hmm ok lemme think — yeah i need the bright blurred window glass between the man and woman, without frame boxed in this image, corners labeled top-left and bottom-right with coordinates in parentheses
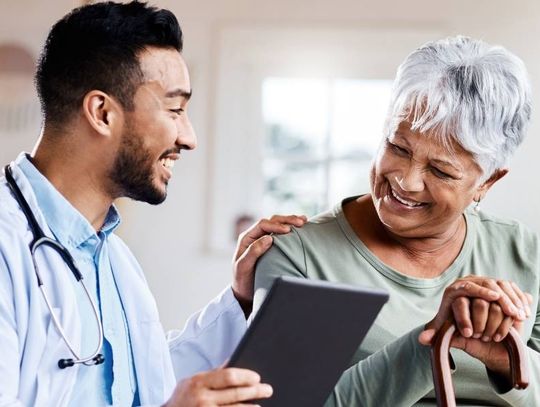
top-left (262, 77), bottom-right (392, 215)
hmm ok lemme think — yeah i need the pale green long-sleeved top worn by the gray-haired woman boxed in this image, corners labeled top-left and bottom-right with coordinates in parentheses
top-left (254, 198), bottom-right (540, 407)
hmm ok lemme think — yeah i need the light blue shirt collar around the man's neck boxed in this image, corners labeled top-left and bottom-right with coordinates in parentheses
top-left (16, 154), bottom-right (120, 248)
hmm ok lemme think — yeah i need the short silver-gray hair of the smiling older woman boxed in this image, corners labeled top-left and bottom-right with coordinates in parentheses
top-left (385, 36), bottom-right (531, 180)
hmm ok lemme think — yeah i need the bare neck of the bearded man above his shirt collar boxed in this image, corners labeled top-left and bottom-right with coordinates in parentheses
top-left (31, 140), bottom-right (113, 231)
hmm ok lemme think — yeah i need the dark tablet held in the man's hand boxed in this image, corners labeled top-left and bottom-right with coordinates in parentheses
top-left (228, 277), bottom-right (388, 407)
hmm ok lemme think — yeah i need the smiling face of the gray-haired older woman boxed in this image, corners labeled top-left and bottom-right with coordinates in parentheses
top-left (371, 121), bottom-right (489, 238)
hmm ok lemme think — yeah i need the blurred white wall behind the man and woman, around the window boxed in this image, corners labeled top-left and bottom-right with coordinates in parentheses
top-left (0, 0), bottom-right (540, 328)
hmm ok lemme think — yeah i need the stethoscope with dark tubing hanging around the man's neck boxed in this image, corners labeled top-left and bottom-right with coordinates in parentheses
top-left (4, 165), bottom-right (105, 369)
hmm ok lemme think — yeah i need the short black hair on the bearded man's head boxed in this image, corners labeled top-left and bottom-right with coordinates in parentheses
top-left (35, 1), bottom-right (182, 126)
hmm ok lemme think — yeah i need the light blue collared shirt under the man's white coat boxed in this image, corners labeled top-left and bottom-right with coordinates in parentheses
top-left (19, 157), bottom-right (139, 406)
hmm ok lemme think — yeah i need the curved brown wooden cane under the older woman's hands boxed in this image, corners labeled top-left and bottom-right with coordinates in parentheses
top-left (431, 321), bottom-right (529, 407)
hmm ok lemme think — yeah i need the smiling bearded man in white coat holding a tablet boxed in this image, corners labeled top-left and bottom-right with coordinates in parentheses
top-left (0, 2), bottom-right (305, 406)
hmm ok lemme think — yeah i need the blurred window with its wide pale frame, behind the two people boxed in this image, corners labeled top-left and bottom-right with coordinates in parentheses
top-left (207, 24), bottom-right (441, 252)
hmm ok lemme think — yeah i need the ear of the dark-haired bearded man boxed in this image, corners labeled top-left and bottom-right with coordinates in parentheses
top-left (82, 90), bottom-right (122, 136)
